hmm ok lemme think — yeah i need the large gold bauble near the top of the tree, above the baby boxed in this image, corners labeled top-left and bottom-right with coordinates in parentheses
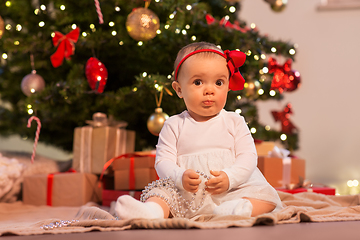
top-left (126, 8), bottom-right (160, 41)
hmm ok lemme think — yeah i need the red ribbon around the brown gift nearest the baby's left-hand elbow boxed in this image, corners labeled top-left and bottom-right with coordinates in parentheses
top-left (98, 153), bottom-right (156, 189)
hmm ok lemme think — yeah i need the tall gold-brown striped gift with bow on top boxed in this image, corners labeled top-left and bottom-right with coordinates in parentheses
top-left (72, 113), bottom-right (135, 174)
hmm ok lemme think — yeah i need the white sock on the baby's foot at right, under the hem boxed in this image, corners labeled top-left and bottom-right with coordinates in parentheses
top-left (214, 199), bottom-right (252, 217)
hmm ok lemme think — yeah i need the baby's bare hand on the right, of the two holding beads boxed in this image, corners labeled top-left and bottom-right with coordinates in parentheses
top-left (205, 170), bottom-right (230, 194)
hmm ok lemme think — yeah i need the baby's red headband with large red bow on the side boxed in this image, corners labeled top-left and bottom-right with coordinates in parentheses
top-left (175, 49), bottom-right (246, 91)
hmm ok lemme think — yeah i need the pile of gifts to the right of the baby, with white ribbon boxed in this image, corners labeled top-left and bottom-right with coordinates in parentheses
top-left (255, 142), bottom-right (335, 195)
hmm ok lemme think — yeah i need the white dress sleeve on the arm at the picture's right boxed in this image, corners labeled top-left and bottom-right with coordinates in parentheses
top-left (223, 116), bottom-right (257, 190)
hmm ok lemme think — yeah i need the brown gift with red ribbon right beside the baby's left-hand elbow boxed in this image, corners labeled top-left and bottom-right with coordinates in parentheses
top-left (112, 152), bottom-right (158, 190)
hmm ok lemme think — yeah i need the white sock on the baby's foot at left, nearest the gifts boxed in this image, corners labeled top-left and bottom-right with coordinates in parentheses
top-left (115, 195), bottom-right (164, 220)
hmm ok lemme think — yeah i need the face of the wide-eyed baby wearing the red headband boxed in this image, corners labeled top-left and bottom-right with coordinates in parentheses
top-left (173, 54), bottom-right (229, 121)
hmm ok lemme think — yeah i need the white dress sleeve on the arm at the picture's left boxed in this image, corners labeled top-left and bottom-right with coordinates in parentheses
top-left (155, 119), bottom-right (185, 190)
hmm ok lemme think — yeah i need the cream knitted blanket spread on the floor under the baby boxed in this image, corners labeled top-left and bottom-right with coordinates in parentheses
top-left (0, 192), bottom-right (360, 236)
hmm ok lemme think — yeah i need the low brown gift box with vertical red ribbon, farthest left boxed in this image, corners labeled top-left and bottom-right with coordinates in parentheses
top-left (23, 173), bottom-right (101, 206)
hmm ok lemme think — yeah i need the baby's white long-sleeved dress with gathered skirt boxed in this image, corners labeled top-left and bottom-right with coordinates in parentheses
top-left (142, 110), bottom-right (282, 218)
